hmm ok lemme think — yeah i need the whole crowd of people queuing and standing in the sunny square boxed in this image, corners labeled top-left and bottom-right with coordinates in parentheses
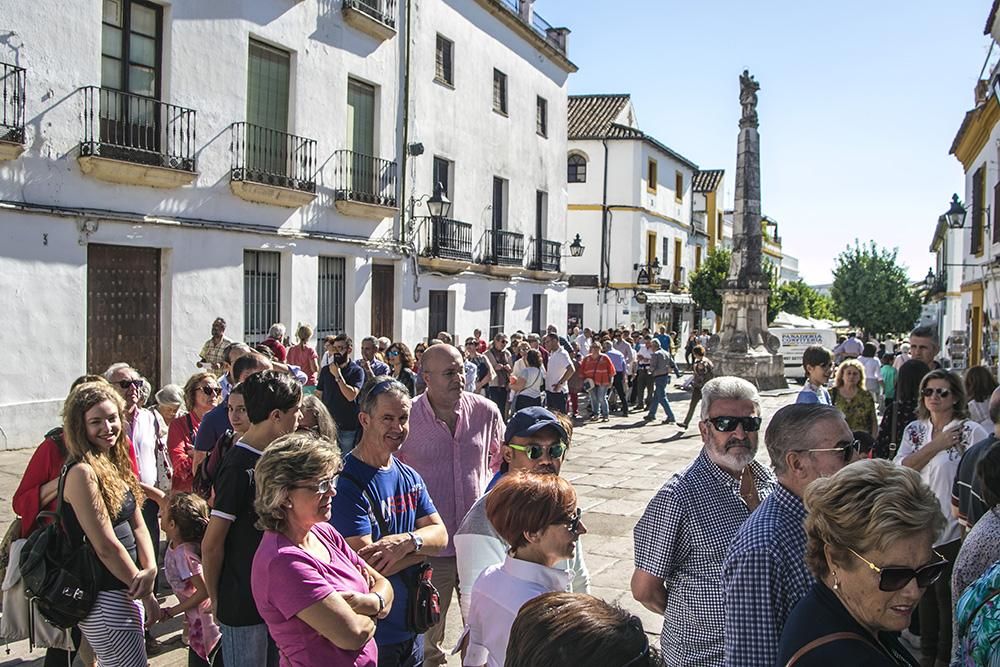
top-left (7, 318), bottom-right (1000, 667)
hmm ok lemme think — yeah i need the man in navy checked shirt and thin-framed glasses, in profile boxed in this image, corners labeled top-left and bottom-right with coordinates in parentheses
top-left (722, 403), bottom-right (860, 667)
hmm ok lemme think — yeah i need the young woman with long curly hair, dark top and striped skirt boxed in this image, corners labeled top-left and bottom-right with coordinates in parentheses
top-left (63, 382), bottom-right (159, 665)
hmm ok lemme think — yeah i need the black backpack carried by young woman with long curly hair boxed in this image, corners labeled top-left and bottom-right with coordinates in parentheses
top-left (19, 462), bottom-right (98, 629)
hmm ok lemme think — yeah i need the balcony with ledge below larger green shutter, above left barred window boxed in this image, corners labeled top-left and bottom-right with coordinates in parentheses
top-left (229, 122), bottom-right (316, 208)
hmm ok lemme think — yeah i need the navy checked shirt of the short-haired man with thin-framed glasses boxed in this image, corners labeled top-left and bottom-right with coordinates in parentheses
top-left (722, 484), bottom-right (816, 667)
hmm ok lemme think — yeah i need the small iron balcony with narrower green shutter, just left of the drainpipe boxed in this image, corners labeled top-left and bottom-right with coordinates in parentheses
top-left (333, 151), bottom-right (397, 220)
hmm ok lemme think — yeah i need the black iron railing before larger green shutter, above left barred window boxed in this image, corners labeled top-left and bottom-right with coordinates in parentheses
top-left (229, 122), bottom-right (316, 193)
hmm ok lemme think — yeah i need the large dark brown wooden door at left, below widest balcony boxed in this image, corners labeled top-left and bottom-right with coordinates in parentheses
top-left (87, 243), bottom-right (160, 391)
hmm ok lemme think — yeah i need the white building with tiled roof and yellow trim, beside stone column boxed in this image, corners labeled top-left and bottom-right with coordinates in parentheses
top-left (566, 95), bottom-right (708, 339)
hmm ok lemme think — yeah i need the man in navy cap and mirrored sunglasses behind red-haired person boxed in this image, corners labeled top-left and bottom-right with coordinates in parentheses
top-left (452, 406), bottom-right (590, 618)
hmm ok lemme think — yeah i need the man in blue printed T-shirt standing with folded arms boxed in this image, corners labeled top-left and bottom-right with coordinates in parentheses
top-left (330, 376), bottom-right (448, 667)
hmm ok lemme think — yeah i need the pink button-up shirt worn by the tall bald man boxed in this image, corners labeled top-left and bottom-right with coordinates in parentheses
top-left (396, 391), bottom-right (504, 556)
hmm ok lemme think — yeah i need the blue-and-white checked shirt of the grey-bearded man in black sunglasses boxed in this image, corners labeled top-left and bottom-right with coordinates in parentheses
top-left (633, 449), bottom-right (775, 667)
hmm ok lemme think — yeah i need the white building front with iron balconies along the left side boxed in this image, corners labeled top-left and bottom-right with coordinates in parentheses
top-left (0, 0), bottom-right (574, 448)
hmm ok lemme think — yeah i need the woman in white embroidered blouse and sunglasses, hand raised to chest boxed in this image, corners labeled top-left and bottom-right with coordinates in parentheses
top-left (894, 370), bottom-right (987, 664)
